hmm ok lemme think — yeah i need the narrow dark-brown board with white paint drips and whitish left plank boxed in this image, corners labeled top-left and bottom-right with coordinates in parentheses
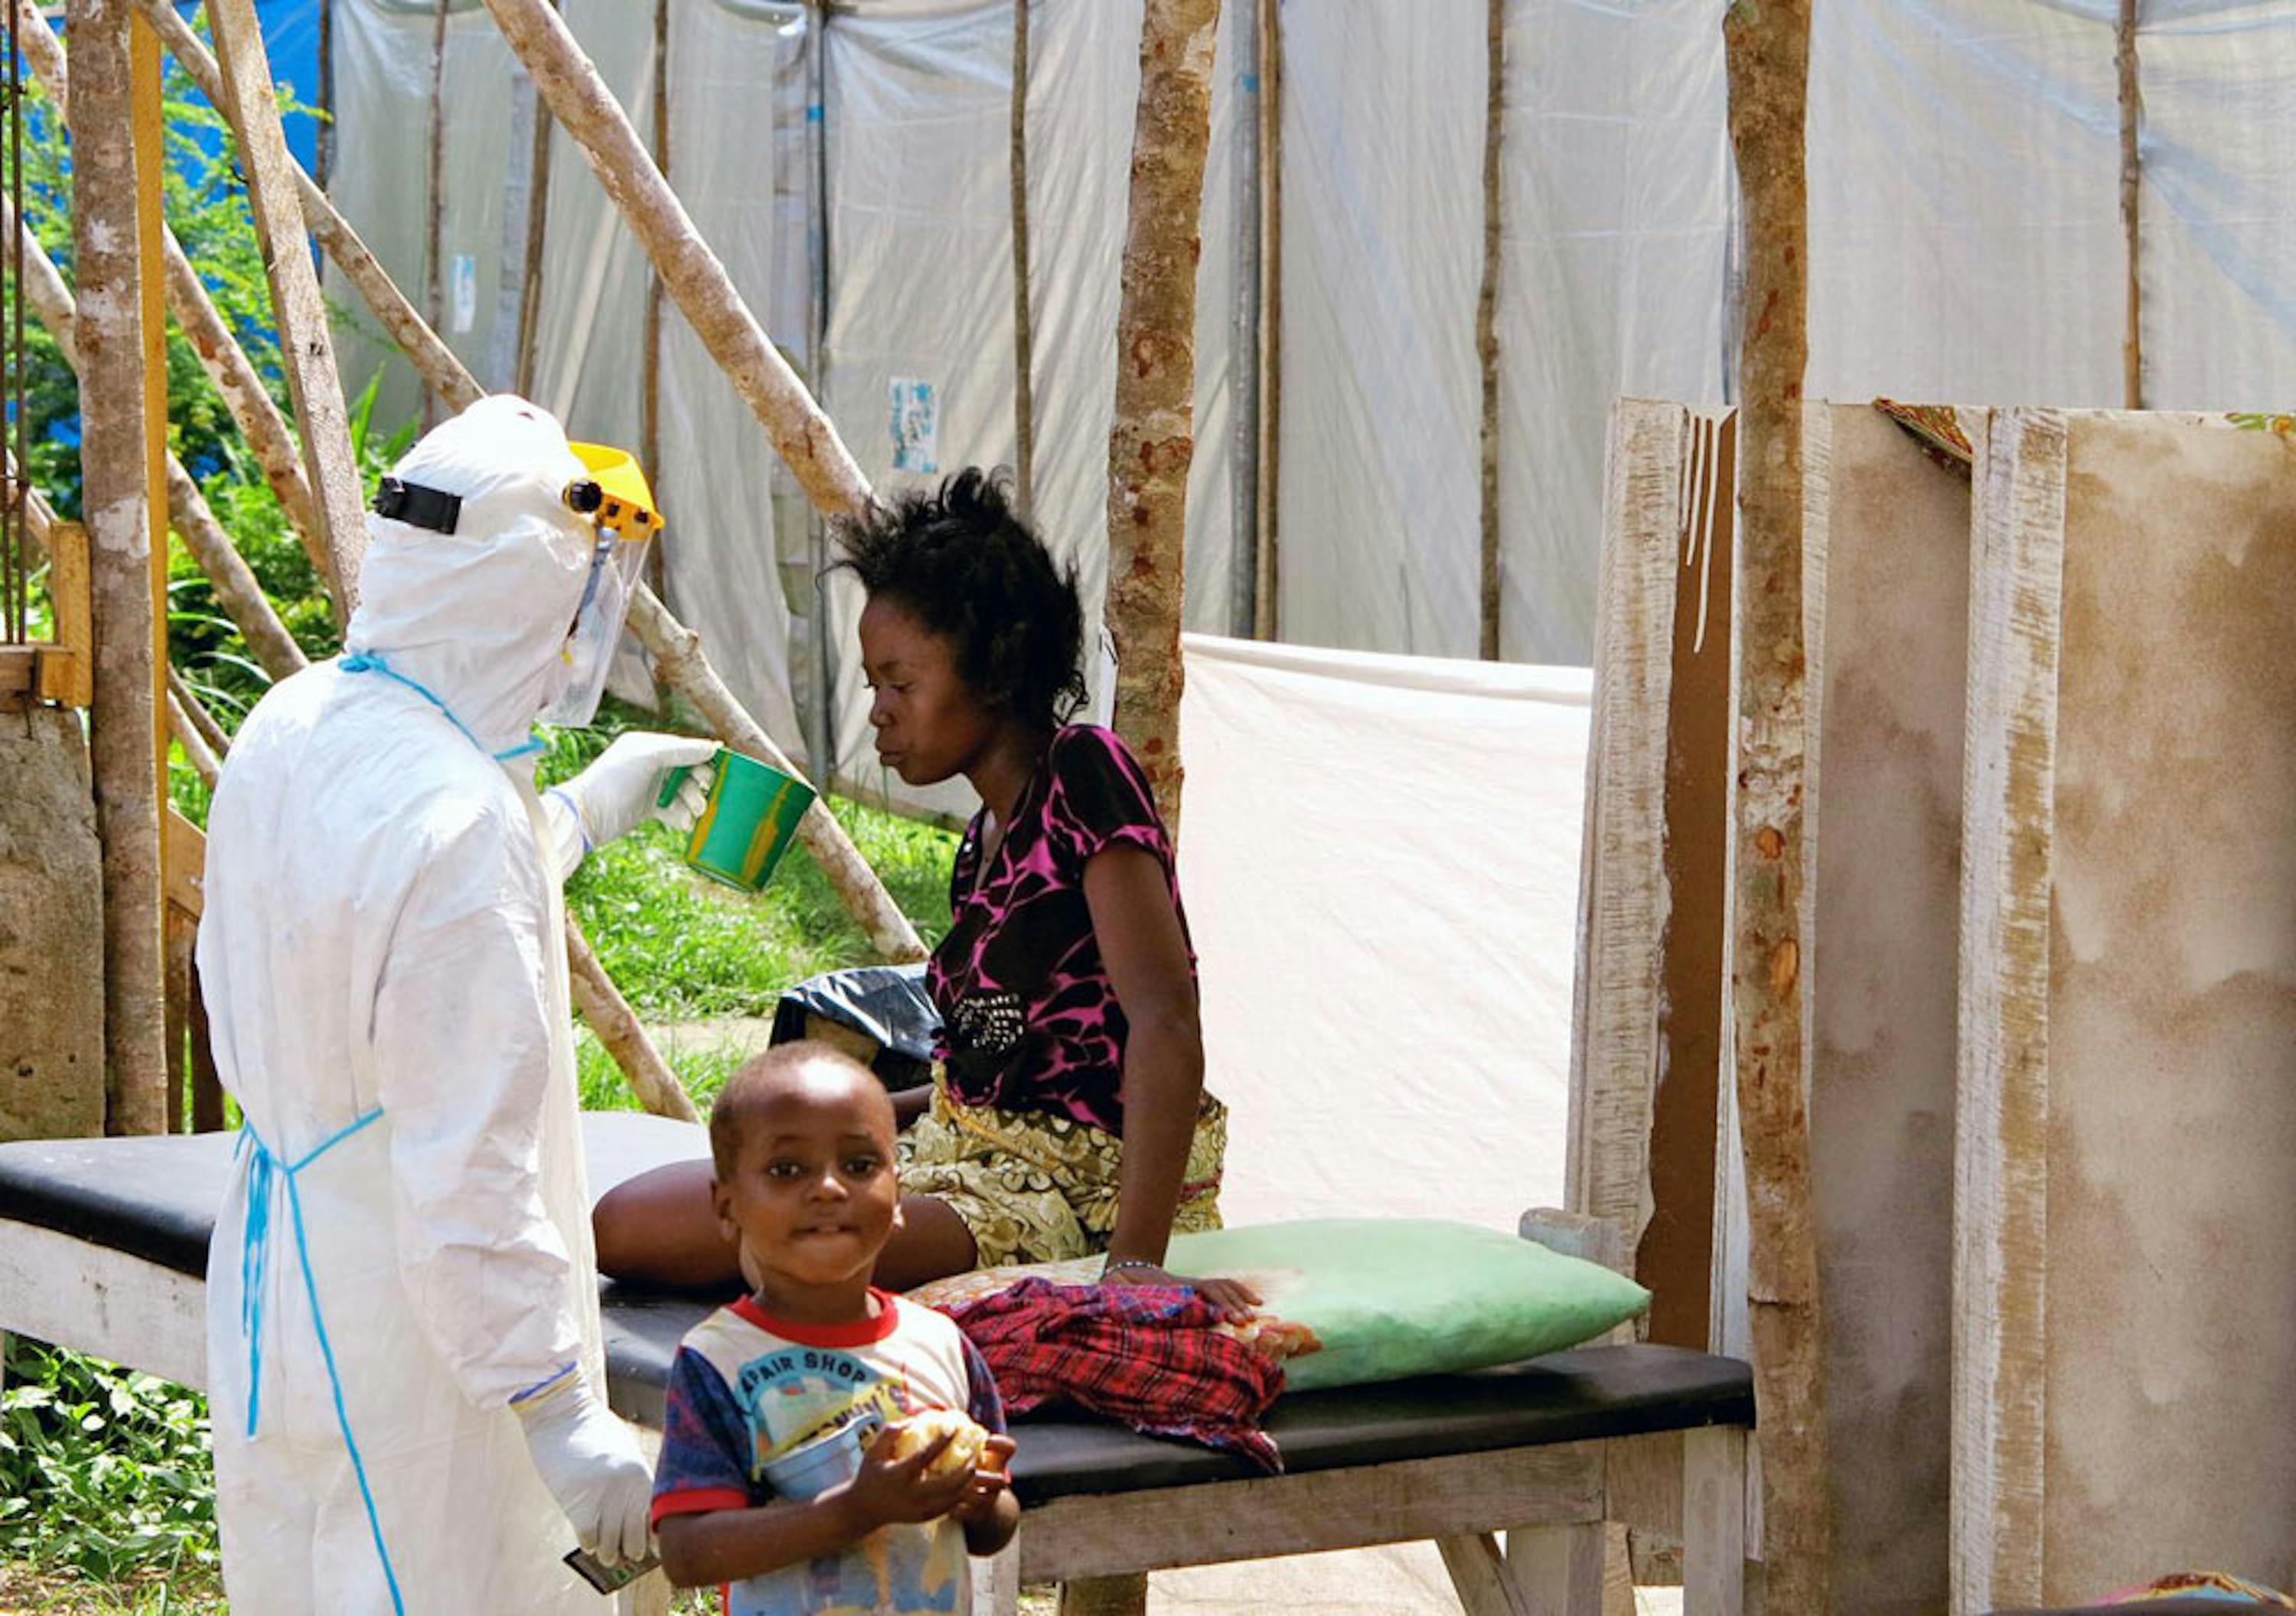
top-left (1564, 399), bottom-right (1731, 1295)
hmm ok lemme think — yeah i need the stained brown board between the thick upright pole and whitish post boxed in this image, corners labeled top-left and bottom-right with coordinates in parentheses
top-left (1805, 404), bottom-right (1970, 1616)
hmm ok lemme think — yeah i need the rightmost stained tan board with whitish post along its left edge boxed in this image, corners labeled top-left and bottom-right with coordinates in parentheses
top-left (1954, 411), bottom-right (2296, 1611)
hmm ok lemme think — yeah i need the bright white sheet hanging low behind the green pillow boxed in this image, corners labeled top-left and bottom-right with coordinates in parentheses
top-left (1180, 636), bottom-right (1589, 1228)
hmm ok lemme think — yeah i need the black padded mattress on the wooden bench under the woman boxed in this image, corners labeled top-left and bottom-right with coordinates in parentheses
top-left (0, 1113), bottom-right (1754, 1504)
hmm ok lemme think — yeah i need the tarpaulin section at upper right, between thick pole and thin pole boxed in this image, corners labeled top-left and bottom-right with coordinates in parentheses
top-left (1802, 0), bottom-right (2124, 404)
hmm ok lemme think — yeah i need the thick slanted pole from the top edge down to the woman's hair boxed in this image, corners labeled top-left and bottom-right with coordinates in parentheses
top-left (480, 0), bottom-right (870, 516)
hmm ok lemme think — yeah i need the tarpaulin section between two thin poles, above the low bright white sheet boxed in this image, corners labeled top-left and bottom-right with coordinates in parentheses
top-left (1277, 0), bottom-right (1488, 656)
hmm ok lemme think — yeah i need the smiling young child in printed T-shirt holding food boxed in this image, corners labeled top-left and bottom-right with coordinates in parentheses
top-left (654, 1042), bottom-right (1019, 1616)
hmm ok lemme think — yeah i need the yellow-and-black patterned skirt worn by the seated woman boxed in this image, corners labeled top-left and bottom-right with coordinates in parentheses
top-left (900, 1067), bottom-right (1228, 1267)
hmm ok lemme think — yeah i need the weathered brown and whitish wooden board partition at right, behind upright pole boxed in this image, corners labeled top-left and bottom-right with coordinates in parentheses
top-left (1598, 404), bottom-right (2296, 1614)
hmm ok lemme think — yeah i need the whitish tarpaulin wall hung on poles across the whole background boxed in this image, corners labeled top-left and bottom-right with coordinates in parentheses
top-left (333, 0), bottom-right (2296, 771)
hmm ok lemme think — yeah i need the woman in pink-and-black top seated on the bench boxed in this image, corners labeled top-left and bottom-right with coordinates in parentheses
top-left (592, 471), bottom-right (1258, 1315)
